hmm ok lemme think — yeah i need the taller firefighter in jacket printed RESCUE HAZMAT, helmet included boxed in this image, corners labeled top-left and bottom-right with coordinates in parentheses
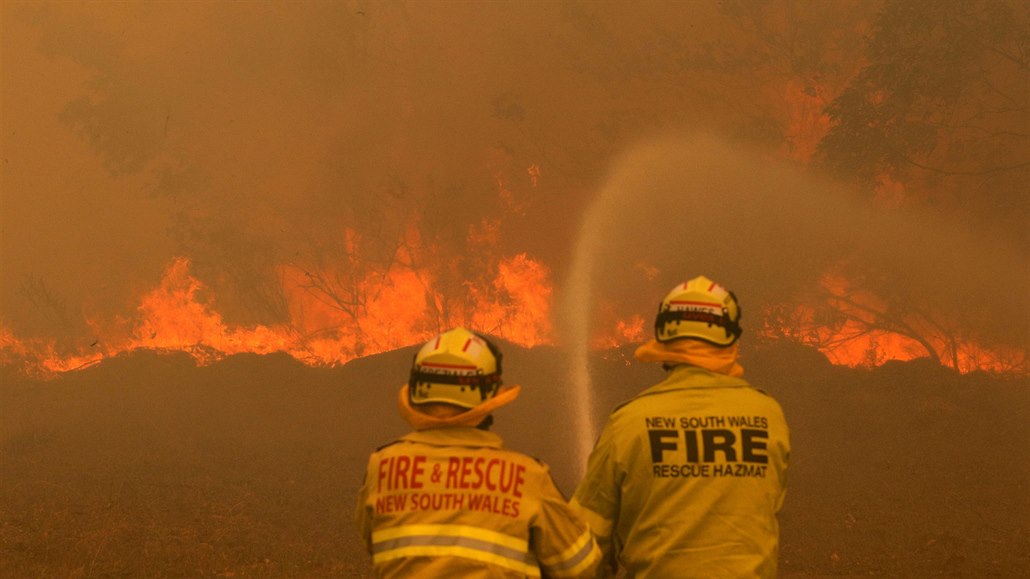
top-left (572, 276), bottom-right (790, 579)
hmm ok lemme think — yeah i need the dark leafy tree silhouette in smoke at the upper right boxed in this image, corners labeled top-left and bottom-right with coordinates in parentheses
top-left (819, 0), bottom-right (1030, 229)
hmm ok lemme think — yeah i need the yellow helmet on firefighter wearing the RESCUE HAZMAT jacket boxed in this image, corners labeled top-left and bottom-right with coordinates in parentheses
top-left (654, 275), bottom-right (742, 347)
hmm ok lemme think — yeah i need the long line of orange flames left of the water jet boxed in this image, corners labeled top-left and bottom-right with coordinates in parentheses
top-left (0, 235), bottom-right (552, 375)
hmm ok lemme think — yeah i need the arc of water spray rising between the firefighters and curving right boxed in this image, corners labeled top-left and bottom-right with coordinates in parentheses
top-left (561, 134), bottom-right (1030, 478)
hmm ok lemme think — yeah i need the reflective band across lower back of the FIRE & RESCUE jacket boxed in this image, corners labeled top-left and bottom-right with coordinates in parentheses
top-left (372, 524), bottom-right (540, 577)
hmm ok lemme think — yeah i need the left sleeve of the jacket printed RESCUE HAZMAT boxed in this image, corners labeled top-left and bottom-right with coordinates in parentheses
top-left (572, 423), bottom-right (623, 577)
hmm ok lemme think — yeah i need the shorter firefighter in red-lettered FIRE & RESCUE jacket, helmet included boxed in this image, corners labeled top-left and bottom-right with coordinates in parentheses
top-left (357, 328), bottom-right (600, 578)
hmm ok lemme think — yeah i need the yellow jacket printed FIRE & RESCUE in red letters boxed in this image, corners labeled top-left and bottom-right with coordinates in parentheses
top-left (357, 427), bottom-right (600, 578)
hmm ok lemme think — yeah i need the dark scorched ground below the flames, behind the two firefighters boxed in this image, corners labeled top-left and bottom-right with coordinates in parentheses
top-left (0, 339), bottom-right (1030, 579)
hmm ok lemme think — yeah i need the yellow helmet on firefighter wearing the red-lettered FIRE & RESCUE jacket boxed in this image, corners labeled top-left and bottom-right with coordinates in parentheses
top-left (408, 328), bottom-right (501, 408)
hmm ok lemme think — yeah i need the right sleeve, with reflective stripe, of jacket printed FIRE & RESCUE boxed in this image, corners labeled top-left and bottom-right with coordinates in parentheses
top-left (529, 467), bottom-right (600, 578)
